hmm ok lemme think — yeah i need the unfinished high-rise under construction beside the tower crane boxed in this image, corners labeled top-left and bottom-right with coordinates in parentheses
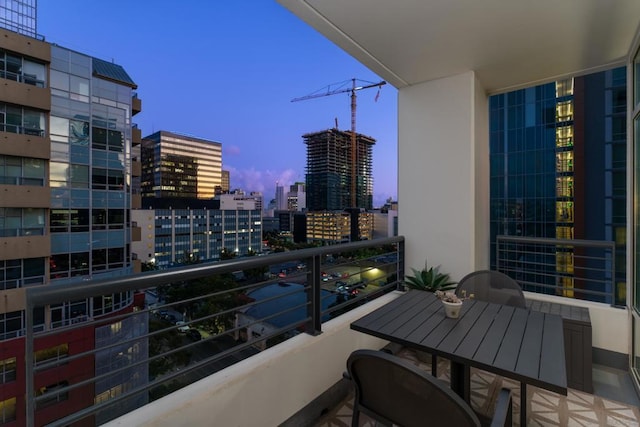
top-left (302, 128), bottom-right (376, 211)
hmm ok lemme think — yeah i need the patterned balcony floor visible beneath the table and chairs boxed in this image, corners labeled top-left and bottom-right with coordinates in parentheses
top-left (315, 349), bottom-right (640, 427)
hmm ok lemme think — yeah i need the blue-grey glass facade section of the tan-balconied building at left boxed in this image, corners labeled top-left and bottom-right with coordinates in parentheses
top-left (49, 46), bottom-right (136, 281)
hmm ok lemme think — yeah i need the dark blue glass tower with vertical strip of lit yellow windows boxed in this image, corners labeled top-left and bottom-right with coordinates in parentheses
top-left (490, 67), bottom-right (627, 303)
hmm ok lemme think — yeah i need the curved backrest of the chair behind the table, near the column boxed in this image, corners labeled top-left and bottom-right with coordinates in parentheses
top-left (456, 270), bottom-right (526, 308)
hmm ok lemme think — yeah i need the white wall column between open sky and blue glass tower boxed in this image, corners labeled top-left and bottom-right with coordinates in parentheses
top-left (398, 71), bottom-right (489, 281)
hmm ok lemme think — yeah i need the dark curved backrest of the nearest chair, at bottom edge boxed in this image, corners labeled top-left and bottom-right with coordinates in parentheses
top-left (347, 350), bottom-right (480, 427)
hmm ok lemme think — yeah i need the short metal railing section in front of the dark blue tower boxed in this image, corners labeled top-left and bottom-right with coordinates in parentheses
top-left (496, 236), bottom-right (625, 306)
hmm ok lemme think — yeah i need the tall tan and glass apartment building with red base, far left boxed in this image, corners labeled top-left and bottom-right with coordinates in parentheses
top-left (0, 15), bottom-right (147, 425)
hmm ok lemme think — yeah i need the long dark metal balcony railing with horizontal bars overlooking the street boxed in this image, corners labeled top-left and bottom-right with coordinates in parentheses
top-left (23, 237), bottom-right (404, 426)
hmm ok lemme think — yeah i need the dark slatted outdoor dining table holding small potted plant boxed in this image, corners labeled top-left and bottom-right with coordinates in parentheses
top-left (351, 290), bottom-right (567, 426)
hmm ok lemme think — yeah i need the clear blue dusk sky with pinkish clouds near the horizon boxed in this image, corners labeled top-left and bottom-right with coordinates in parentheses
top-left (38, 0), bottom-right (398, 206)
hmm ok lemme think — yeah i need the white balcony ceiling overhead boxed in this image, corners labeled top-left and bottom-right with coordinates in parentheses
top-left (277, 0), bottom-right (640, 93)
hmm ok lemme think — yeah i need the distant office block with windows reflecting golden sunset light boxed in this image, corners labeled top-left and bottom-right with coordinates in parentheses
top-left (140, 131), bottom-right (222, 199)
